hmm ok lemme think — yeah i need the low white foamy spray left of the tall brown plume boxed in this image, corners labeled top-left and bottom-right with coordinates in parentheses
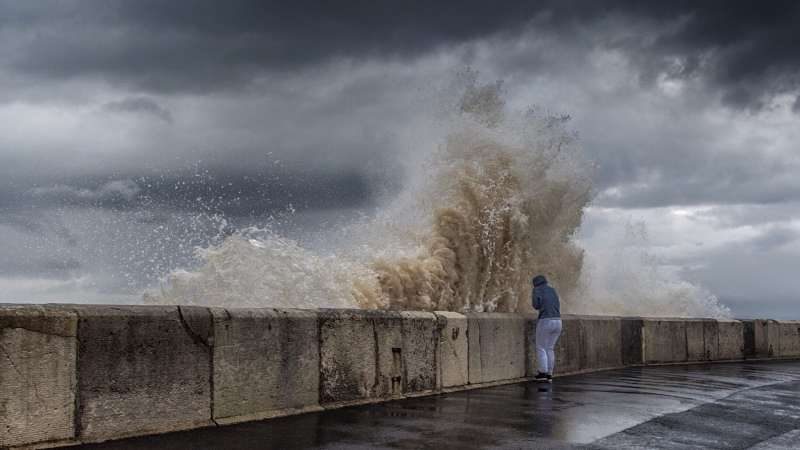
top-left (145, 228), bottom-right (375, 308)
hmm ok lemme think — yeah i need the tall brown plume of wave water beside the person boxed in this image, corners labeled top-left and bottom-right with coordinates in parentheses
top-left (366, 121), bottom-right (589, 311)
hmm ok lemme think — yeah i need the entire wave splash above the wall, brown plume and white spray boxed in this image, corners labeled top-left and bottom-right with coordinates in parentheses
top-left (145, 72), bottom-right (729, 317)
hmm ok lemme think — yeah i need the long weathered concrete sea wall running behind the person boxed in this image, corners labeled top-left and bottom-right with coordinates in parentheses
top-left (0, 305), bottom-right (800, 448)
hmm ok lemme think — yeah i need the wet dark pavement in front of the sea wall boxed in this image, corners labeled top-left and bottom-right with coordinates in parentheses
top-left (73, 362), bottom-right (800, 450)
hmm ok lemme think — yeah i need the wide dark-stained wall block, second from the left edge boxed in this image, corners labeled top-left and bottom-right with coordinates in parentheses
top-left (76, 305), bottom-right (212, 440)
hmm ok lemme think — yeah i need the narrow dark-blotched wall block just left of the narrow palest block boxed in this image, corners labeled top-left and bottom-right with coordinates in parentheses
top-left (400, 312), bottom-right (439, 394)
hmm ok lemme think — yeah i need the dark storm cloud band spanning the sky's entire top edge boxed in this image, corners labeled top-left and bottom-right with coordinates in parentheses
top-left (0, 0), bottom-right (800, 107)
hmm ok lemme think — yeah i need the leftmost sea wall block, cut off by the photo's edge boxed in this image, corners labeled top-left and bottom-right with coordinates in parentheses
top-left (0, 306), bottom-right (78, 447)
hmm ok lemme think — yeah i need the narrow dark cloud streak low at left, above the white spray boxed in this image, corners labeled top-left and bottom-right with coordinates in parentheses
top-left (0, 170), bottom-right (373, 216)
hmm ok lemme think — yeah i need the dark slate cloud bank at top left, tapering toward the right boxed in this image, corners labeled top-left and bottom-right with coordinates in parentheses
top-left (3, 1), bottom-right (536, 92)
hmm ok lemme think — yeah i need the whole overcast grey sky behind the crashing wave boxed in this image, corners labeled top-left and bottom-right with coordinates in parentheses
top-left (0, 0), bottom-right (800, 318)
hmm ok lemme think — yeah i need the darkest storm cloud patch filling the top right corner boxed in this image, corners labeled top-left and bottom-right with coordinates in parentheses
top-left (620, 1), bottom-right (800, 108)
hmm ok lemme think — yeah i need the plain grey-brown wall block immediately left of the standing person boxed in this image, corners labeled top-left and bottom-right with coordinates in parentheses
top-left (467, 313), bottom-right (526, 384)
